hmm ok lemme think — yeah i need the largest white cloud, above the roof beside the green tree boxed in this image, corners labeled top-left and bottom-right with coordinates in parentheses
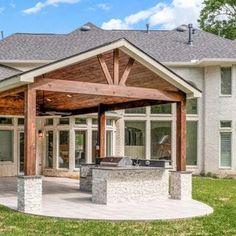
top-left (102, 0), bottom-right (203, 29)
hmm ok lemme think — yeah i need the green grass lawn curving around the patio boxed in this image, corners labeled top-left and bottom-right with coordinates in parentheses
top-left (0, 177), bottom-right (236, 236)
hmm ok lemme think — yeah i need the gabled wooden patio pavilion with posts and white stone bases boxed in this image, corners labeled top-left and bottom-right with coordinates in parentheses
top-left (0, 39), bottom-right (205, 218)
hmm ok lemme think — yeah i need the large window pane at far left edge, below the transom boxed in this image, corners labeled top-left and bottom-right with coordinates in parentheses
top-left (0, 130), bottom-right (13, 161)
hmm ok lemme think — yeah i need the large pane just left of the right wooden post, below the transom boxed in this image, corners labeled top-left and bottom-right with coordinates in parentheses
top-left (151, 121), bottom-right (171, 160)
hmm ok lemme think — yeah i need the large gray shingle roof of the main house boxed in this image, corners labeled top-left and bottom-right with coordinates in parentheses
top-left (0, 23), bottom-right (236, 62)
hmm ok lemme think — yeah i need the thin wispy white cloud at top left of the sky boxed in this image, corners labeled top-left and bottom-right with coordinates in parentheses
top-left (23, 0), bottom-right (80, 14)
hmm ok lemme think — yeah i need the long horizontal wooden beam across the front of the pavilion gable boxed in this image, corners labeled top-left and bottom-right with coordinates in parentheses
top-left (31, 79), bottom-right (183, 102)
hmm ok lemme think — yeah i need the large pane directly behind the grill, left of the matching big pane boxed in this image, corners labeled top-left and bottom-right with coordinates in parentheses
top-left (125, 121), bottom-right (145, 159)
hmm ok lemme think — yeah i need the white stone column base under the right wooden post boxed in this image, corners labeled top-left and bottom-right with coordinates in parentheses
top-left (170, 171), bottom-right (192, 200)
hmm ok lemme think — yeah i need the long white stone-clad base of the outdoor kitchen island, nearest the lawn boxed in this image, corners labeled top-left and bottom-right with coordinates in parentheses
top-left (92, 167), bottom-right (169, 204)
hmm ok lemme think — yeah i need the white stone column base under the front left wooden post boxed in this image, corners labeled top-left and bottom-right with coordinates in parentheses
top-left (17, 176), bottom-right (42, 213)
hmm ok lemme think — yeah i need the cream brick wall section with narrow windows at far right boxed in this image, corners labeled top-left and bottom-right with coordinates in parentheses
top-left (204, 65), bottom-right (236, 175)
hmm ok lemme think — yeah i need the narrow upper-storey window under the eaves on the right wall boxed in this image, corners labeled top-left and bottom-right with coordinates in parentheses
top-left (221, 67), bottom-right (232, 95)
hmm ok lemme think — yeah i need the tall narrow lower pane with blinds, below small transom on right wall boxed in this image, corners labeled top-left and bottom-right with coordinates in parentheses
top-left (220, 132), bottom-right (231, 167)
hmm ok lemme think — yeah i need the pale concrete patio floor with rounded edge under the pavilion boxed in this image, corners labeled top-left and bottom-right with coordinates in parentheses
top-left (0, 177), bottom-right (213, 220)
